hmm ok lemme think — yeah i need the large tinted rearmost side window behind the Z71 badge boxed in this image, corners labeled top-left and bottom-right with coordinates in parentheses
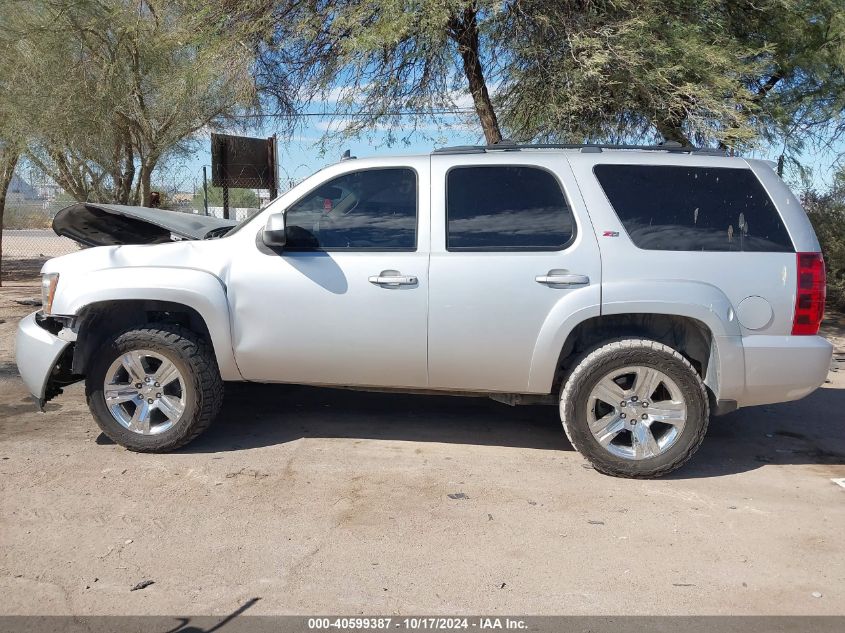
top-left (594, 165), bottom-right (795, 252)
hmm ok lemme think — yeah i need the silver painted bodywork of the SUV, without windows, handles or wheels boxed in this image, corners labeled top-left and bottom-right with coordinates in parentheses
top-left (19, 151), bottom-right (831, 406)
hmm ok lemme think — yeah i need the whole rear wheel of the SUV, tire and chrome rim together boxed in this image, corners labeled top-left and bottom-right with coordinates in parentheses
top-left (560, 338), bottom-right (710, 479)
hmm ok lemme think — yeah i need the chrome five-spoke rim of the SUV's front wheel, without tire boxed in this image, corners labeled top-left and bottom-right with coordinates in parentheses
top-left (103, 349), bottom-right (185, 435)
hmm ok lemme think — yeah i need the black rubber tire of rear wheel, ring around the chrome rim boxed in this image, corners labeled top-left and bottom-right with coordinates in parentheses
top-left (560, 338), bottom-right (710, 479)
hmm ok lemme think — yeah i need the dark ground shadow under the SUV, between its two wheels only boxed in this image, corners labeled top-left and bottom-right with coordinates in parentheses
top-left (183, 383), bottom-right (572, 453)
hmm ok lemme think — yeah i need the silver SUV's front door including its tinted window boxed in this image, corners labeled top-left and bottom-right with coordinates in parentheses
top-left (228, 157), bottom-right (429, 388)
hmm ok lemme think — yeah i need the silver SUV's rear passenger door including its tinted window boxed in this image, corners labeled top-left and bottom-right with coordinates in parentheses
top-left (428, 152), bottom-right (601, 392)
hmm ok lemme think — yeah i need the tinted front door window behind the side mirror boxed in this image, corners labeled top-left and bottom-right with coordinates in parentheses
top-left (285, 168), bottom-right (417, 251)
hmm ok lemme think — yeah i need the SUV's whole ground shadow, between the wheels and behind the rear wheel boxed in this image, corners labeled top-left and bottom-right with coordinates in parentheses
top-left (168, 383), bottom-right (845, 479)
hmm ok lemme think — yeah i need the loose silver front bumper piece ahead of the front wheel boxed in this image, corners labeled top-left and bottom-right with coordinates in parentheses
top-left (15, 312), bottom-right (70, 408)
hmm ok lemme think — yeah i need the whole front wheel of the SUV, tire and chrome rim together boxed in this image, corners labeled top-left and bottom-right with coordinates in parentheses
top-left (85, 323), bottom-right (223, 453)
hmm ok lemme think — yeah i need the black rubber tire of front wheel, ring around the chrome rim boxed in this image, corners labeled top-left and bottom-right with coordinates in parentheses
top-left (85, 323), bottom-right (223, 453)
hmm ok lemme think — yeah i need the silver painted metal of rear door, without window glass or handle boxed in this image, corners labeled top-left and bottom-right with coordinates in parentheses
top-left (428, 153), bottom-right (602, 393)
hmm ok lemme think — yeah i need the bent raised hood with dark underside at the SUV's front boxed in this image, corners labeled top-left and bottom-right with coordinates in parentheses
top-left (53, 202), bottom-right (237, 246)
